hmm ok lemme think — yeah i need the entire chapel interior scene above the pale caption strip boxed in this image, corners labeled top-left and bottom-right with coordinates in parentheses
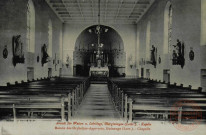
top-left (0, 0), bottom-right (206, 134)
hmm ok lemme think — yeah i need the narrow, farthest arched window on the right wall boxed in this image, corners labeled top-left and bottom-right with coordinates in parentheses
top-left (146, 21), bottom-right (151, 60)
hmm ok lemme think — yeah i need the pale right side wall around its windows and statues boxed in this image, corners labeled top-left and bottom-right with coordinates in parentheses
top-left (137, 0), bottom-right (201, 88)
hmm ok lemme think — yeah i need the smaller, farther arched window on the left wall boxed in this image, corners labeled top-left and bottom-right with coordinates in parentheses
top-left (48, 20), bottom-right (52, 57)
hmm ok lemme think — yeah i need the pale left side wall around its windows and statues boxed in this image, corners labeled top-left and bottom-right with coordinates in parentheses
top-left (0, 0), bottom-right (62, 85)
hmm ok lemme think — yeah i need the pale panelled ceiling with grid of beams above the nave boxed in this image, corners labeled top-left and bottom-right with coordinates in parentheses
top-left (46, 0), bottom-right (155, 24)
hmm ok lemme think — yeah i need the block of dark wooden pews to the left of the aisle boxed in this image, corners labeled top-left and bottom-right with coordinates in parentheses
top-left (0, 78), bottom-right (90, 120)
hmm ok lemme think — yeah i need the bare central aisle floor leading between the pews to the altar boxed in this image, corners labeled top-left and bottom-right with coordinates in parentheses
top-left (75, 84), bottom-right (120, 120)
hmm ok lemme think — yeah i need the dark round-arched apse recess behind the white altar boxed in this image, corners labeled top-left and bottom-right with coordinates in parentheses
top-left (73, 25), bottom-right (126, 77)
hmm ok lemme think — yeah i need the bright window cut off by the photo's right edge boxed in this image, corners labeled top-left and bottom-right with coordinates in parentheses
top-left (201, 0), bottom-right (206, 46)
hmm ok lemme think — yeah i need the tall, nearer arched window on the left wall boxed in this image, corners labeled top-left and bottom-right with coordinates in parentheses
top-left (27, 0), bottom-right (35, 53)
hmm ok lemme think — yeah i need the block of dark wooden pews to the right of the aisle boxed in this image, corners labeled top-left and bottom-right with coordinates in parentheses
top-left (108, 78), bottom-right (206, 122)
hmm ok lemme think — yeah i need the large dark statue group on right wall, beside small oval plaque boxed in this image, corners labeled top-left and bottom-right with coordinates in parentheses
top-left (172, 39), bottom-right (185, 68)
